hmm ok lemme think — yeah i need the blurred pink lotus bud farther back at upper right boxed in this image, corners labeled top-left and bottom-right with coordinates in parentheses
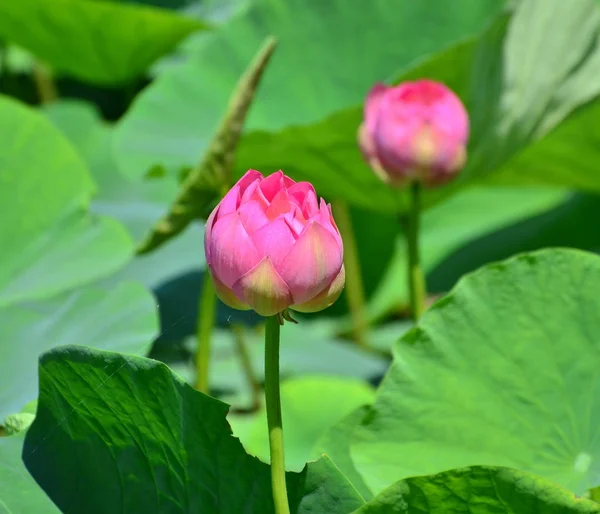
top-left (358, 80), bottom-right (469, 186)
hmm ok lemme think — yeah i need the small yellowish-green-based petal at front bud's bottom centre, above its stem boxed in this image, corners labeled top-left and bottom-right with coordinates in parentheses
top-left (233, 257), bottom-right (293, 316)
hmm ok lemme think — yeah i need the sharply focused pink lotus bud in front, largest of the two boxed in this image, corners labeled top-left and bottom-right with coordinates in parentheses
top-left (204, 170), bottom-right (344, 316)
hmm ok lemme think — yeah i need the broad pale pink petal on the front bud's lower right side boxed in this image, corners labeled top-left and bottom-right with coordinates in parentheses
top-left (277, 221), bottom-right (343, 304)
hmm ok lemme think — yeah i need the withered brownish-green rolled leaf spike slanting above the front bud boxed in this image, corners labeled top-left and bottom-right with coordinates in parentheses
top-left (137, 36), bottom-right (277, 255)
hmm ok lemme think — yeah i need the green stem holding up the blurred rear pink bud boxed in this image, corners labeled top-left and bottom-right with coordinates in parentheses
top-left (406, 181), bottom-right (427, 321)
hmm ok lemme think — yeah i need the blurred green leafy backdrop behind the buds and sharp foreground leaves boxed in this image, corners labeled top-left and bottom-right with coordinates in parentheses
top-left (0, 0), bottom-right (600, 508)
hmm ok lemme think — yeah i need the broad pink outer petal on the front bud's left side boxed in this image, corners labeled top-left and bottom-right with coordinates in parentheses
top-left (209, 212), bottom-right (260, 288)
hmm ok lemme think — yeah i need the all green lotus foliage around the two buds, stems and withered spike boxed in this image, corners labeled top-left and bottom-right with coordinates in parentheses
top-left (0, 0), bottom-right (600, 514)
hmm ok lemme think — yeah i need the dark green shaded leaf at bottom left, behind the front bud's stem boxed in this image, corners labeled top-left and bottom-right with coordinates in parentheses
top-left (23, 347), bottom-right (363, 514)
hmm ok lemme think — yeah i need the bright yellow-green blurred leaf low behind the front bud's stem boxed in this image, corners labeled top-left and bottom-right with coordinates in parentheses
top-left (228, 376), bottom-right (374, 471)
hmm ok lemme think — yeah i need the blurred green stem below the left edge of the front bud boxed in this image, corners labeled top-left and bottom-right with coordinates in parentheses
top-left (196, 271), bottom-right (217, 394)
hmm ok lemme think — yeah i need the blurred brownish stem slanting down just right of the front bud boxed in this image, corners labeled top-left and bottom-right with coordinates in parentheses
top-left (332, 201), bottom-right (369, 348)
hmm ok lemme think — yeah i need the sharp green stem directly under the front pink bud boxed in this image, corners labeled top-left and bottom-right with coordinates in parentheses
top-left (265, 315), bottom-right (290, 514)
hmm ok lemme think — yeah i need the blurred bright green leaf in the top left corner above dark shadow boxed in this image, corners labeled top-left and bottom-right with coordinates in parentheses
top-left (0, 0), bottom-right (204, 84)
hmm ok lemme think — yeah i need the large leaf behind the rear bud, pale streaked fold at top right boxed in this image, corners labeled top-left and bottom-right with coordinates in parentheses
top-left (238, 0), bottom-right (600, 211)
